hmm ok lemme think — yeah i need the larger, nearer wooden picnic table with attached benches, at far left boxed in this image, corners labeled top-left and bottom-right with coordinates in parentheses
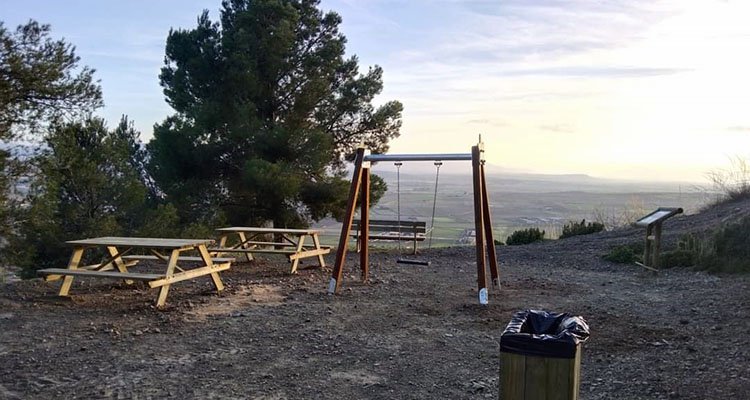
top-left (38, 237), bottom-right (233, 307)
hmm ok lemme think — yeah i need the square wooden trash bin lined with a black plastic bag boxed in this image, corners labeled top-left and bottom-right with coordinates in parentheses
top-left (500, 310), bottom-right (589, 400)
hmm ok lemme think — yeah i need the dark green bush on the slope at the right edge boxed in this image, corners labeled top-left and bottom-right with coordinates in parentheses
top-left (699, 216), bottom-right (750, 273)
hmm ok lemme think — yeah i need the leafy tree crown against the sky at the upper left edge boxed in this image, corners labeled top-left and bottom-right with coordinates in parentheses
top-left (0, 21), bottom-right (102, 140)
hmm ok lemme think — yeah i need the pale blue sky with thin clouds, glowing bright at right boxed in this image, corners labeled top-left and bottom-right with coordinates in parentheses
top-left (0, 0), bottom-right (750, 182)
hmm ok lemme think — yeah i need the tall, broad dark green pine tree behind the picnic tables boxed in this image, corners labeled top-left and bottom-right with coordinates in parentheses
top-left (148, 0), bottom-right (402, 227)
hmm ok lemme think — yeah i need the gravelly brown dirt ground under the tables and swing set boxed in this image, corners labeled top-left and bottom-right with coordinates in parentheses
top-left (0, 205), bottom-right (750, 399)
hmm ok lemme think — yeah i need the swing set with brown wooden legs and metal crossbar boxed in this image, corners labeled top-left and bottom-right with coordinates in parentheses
top-left (328, 137), bottom-right (499, 305)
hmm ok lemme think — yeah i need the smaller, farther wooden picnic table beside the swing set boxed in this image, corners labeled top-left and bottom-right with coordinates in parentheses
top-left (209, 226), bottom-right (331, 274)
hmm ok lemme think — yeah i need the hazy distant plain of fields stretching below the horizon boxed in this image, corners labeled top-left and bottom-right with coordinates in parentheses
top-left (315, 166), bottom-right (714, 247)
